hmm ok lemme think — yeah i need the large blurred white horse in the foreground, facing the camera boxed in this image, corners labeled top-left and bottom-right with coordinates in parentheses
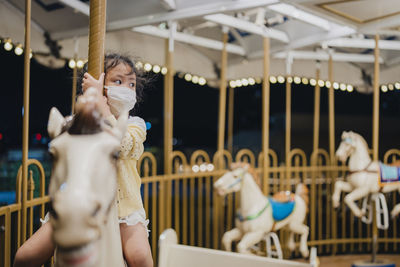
top-left (48, 88), bottom-right (127, 267)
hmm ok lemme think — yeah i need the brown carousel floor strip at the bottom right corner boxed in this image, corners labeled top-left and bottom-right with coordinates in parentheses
top-left (294, 254), bottom-right (400, 267)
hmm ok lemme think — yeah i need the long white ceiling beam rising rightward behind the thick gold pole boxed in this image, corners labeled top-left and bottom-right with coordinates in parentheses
top-left (52, 0), bottom-right (279, 40)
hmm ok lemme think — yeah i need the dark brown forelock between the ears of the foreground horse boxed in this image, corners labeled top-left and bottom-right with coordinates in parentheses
top-left (63, 102), bottom-right (103, 135)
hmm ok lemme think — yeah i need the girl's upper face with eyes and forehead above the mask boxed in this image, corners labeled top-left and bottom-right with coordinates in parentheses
top-left (104, 63), bottom-right (136, 94)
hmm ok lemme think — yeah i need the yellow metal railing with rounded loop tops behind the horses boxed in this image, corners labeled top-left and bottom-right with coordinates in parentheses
top-left (0, 149), bottom-right (400, 267)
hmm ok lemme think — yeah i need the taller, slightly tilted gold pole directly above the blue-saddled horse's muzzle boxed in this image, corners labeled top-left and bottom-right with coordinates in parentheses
top-left (217, 28), bottom-right (228, 169)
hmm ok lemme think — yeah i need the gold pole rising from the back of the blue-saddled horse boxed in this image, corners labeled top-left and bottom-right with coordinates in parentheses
top-left (261, 37), bottom-right (270, 195)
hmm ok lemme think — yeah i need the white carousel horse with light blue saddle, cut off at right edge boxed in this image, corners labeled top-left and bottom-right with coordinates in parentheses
top-left (332, 131), bottom-right (400, 221)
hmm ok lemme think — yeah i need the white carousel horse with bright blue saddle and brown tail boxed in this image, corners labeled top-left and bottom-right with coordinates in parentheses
top-left (214, 163), bottom-right (309, 258)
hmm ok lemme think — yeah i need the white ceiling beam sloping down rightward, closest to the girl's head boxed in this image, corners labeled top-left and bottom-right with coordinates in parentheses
top-left (132, 26), bottom-right (246, 56)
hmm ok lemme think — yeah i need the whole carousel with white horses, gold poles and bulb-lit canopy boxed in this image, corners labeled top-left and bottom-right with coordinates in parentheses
top-left (0, 0), bottom-right (400, 267)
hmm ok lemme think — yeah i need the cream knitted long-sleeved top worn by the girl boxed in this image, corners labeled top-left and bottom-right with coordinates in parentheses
top-left (107, 116), bottom-right (146, 218)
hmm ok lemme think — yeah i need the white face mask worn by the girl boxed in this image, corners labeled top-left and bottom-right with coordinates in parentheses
top-left (104, 86), bottom-right (136, 117)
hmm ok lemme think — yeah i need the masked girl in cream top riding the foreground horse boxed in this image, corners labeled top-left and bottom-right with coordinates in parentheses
top-left (14, 54), bottom-right (153, 267)
